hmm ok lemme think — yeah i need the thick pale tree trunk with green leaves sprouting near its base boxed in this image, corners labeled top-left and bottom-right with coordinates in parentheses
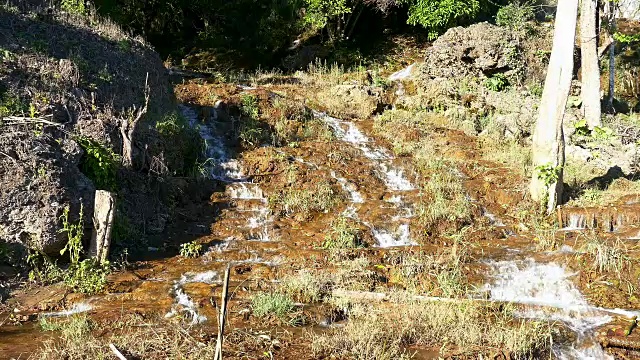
top-left (529, 0), bottom-right (578, 213)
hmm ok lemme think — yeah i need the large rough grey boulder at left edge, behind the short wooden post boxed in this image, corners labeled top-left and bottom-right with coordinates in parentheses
top-left (0, 131), bottom-right (95, 254)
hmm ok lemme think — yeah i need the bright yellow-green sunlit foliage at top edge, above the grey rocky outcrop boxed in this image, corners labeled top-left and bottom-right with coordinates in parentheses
top-left (400, 0), bottom-right (488, 40)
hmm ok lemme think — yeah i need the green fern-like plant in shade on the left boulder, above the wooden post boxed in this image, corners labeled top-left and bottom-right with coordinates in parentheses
top-left (75, 136), bottom-right (120, 190)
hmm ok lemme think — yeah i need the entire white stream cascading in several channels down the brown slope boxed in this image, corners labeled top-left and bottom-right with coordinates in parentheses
top-left (179, 98), bottom-right (636, 360)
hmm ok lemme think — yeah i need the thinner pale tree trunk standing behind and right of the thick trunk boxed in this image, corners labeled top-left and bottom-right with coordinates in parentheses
top-left (580, 0), bottom-right (602, 129)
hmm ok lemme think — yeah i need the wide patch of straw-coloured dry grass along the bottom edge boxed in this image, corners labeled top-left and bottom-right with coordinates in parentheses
top-left (312, 301), bottom-right (551, 360)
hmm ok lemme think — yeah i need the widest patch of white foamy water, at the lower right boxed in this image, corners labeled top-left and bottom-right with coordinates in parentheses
top-left (485, 259), bottom-right (612, 360)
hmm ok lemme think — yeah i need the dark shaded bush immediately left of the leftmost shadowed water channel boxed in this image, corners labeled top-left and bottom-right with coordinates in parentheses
top-left (156, 112), bottom-right (204, 176)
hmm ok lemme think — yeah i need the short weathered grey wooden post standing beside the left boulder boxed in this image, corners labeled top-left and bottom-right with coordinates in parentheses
top-left (89, 190), bottom-right (116, 264)
